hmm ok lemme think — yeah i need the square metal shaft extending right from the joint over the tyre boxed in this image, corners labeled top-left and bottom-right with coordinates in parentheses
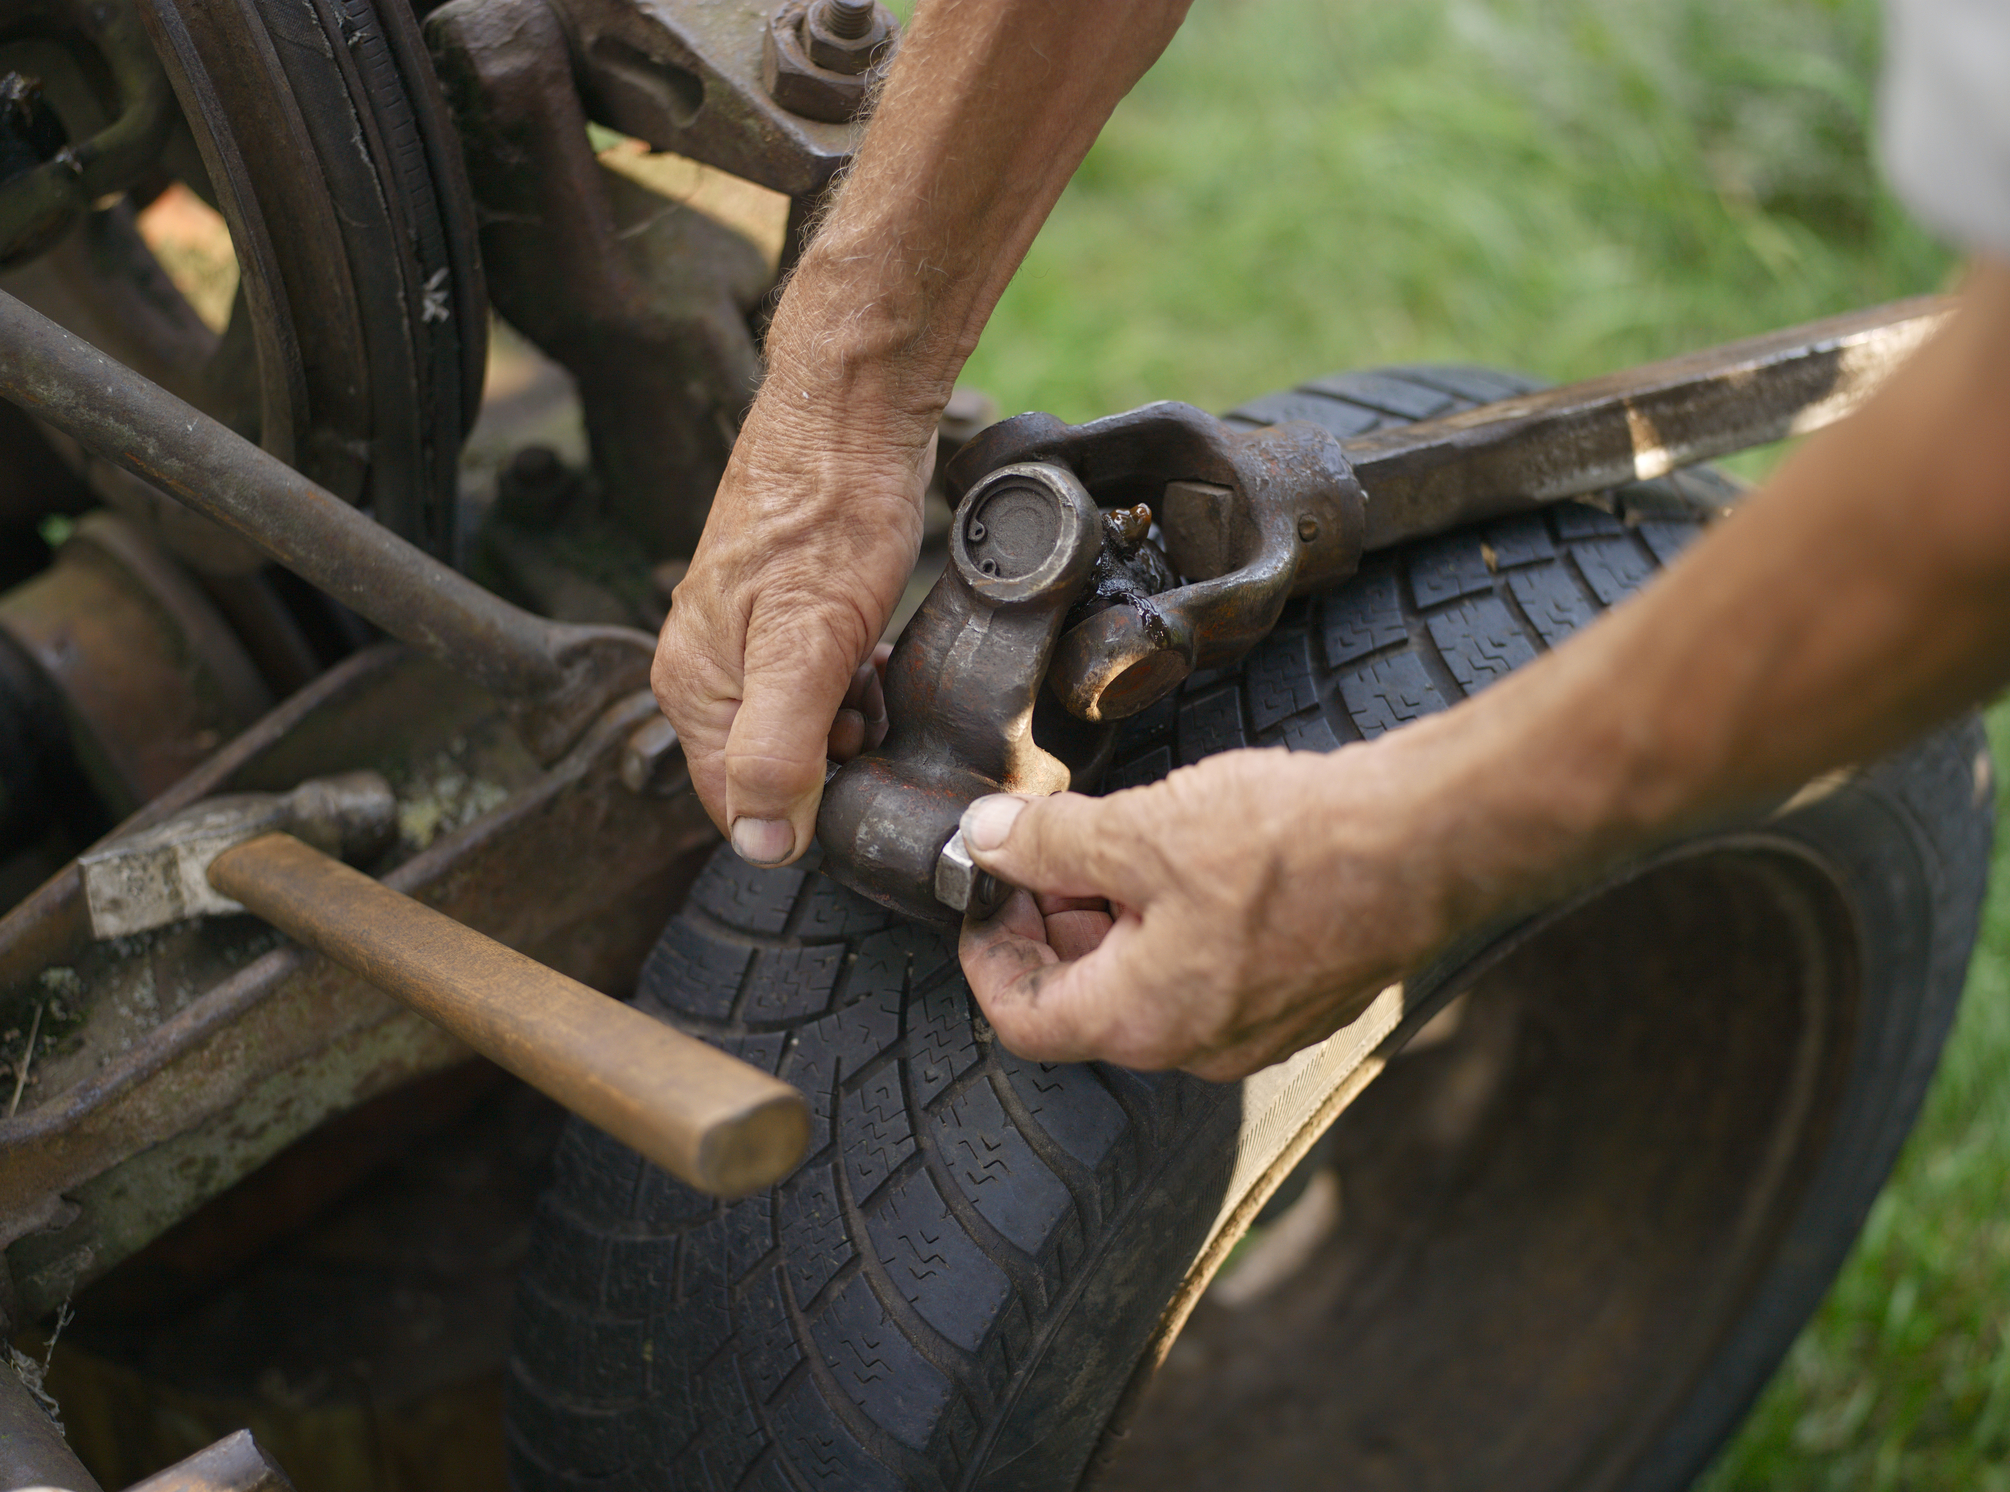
top-left (1343, 296), bottom-right (1952, 549)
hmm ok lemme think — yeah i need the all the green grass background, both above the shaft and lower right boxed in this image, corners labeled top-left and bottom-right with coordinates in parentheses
top-left (967, 0), bottom-right (2010, 1492)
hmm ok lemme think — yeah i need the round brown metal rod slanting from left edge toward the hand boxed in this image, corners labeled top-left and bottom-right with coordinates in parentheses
top-left (0, 292), bottom-right (653, 760)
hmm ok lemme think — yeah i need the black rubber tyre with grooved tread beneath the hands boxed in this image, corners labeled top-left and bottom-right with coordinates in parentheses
top-left (507, 368), bottom-right (1990, 1492)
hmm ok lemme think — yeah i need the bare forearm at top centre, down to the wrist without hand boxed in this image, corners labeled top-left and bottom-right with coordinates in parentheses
top-left (768, 0), bottom-right (1186, 418)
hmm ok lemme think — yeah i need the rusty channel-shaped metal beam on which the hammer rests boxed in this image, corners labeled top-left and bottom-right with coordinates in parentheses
top-left (0, 667), bottom-right (718, 1317)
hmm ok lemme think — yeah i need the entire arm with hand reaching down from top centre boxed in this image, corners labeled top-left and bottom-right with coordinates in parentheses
top-left (651, 0), bottom-right (1186, 865)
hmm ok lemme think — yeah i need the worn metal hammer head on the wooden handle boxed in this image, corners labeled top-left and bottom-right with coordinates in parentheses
top-left (76, 772), bottom-right (398, 939)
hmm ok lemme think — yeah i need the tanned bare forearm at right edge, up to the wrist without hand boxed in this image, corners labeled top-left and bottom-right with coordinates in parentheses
top-left (1407, 265), bottom-right (2010, 928)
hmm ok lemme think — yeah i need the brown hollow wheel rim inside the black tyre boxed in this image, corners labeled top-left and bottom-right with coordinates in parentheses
top-left (1095, 838), bottom-right (1863, 1492)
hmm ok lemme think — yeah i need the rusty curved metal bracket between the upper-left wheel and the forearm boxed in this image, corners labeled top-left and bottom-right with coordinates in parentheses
top-left (426, 0), bottom-right (772, 559)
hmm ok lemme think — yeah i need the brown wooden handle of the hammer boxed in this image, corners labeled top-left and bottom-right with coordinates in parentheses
top-left (209, 834), bottom-right (810, 1196)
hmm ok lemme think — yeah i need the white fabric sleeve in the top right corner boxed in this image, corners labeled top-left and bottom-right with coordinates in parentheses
top-left (1879, 0), bottom-right (2010, 259)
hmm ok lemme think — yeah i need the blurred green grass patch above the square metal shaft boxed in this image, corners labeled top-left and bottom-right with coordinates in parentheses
top-left (969, 0), bottom-right (1948, 450)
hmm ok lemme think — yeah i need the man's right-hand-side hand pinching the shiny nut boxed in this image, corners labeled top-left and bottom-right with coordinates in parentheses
top-left (961, 736), bottom-right (1461, 1082)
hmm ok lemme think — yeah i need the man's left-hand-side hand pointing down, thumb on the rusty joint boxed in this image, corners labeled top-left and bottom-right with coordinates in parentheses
top-left (651, 388), bottom-right (935, 865)
